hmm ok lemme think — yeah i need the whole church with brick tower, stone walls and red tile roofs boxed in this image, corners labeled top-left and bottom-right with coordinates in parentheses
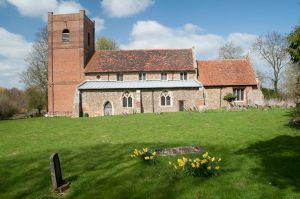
top-left (48, 10), bottom-right (262, 117)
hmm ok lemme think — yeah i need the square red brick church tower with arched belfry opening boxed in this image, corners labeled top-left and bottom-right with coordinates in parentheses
top-left (48, 10), bottom-right (95, 115)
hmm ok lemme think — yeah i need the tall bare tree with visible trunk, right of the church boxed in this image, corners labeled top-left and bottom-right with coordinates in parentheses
top-left (253, 32), bottom-right (290, 93)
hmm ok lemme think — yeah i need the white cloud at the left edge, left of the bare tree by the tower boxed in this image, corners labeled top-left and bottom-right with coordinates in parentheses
top-left (0, 27), bottom-right (31, 87)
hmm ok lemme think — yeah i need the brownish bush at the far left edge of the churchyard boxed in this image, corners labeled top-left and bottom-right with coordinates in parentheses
top-left (0, 94), bottom-right (18, 119)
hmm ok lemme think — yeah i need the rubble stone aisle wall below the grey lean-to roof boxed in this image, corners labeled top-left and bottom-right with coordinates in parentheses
top-left (81, 88), bottom-right (204, 117)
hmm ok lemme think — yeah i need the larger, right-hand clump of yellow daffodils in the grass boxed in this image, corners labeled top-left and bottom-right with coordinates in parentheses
top-left (169, 152), bottom-right (221, 177)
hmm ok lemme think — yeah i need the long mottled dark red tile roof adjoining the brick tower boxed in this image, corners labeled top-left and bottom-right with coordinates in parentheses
top-left (85, 49), bottom-right (195, 73)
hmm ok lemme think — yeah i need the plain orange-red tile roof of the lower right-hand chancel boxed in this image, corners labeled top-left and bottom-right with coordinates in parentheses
top-left (197, 59), bottom-right (257, 86)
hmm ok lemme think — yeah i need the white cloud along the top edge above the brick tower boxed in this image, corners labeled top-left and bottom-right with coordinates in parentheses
top-left (7, 0), bottom-right (84, 21)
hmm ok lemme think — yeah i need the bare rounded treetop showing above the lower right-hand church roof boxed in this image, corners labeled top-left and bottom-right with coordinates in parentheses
top-left (219, 41), bottom-right (244, 59)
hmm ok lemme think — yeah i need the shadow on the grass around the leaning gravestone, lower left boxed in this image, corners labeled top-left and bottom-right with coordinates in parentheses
top-left (0, 144), bottom-right (203, 198)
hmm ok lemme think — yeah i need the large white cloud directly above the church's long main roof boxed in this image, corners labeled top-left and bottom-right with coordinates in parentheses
top-left (121, 21), bottom-right (257, 59)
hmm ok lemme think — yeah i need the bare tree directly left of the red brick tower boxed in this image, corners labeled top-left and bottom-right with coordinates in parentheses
top-left (20, 27), bottom-right (48, 107)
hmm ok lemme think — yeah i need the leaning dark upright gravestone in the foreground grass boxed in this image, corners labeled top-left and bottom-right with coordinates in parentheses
top-left (50, 153), bottom-right (69, 192)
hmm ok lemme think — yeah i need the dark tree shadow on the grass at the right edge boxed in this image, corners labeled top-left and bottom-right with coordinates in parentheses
top-left (237, 135), bottom-right (300, 192)
